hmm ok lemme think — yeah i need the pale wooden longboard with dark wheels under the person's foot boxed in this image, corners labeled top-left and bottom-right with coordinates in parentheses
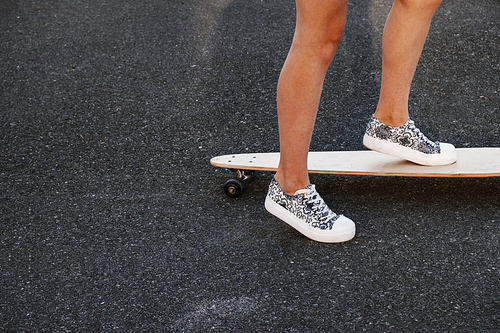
top-left (210, 147), bottom-right (500, 197)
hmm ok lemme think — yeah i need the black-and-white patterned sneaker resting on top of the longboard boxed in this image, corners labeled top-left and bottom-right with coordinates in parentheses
top-left (363, 116), bottom-right (457, 165)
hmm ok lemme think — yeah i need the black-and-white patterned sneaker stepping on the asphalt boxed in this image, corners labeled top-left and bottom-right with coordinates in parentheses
top-left (265, 178), bottom-right (356, 243)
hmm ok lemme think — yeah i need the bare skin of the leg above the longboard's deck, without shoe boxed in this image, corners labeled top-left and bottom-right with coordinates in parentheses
top-left (375, 0), bottom-right (441, 127)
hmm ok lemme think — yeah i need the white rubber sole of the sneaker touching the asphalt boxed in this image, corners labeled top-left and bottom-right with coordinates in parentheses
top-left (264, 197), bottom-right (356, 243)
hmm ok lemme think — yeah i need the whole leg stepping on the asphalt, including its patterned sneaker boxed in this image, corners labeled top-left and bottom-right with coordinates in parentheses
top-left (265, 0), bottom-right (356, 243)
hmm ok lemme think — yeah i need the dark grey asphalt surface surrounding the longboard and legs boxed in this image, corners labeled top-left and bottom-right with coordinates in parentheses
top-left (0, 0), bottom-right (500, 332)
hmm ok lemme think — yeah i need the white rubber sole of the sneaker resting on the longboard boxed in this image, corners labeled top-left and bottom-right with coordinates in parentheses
top-left (363, 134), bottom-right (457, 166)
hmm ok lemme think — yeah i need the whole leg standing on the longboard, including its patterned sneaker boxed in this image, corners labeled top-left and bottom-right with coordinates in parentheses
top-left (363, 0), bottom-right (457, 165)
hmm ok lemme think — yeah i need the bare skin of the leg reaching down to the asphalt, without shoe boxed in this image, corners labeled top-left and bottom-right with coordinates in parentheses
top-left (275, 0), bottom-right (348, 194)
